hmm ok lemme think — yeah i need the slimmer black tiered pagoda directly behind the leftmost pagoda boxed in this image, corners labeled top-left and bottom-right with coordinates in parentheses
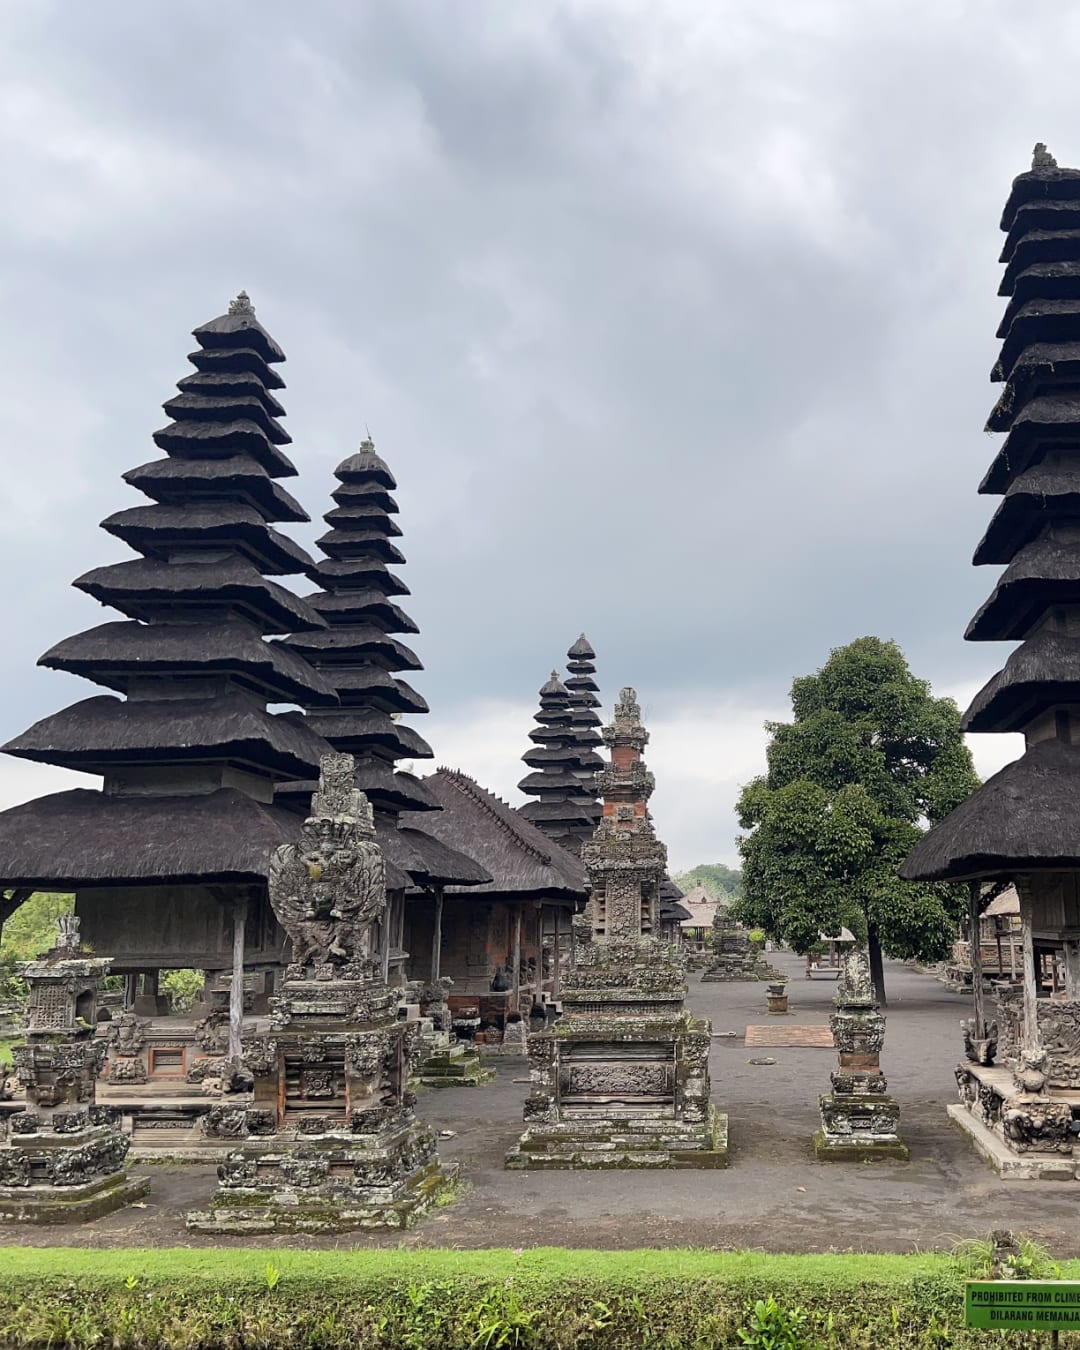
top-left (278, 439), bottom-right (490, 984)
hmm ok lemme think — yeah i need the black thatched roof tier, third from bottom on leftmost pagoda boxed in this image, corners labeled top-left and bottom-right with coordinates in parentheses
top-left (38, 620), bottom-right (338, 705)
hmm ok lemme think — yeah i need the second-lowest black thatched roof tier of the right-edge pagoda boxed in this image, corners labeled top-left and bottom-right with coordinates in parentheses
top-left (964, 629), bottom-right (1080, 732)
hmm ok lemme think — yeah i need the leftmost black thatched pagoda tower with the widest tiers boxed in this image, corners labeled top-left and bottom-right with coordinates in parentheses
top-left (0, 293), bottom-right (338, 1009)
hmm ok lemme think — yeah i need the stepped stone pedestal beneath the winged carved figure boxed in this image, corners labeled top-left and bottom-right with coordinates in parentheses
top-left (188, 972), bottom-right (451, 1233)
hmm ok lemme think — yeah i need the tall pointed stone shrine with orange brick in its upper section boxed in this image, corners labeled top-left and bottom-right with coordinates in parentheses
top-left (506, 689), bottom-right (728, 1169)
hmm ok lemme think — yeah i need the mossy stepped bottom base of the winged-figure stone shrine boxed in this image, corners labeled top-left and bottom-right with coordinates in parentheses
top-left (188, 1112), bottom-right (458, 1233)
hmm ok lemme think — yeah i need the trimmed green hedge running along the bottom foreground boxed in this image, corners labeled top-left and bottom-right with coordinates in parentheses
top-left (0, 1247), bottom-right (1080, 1350)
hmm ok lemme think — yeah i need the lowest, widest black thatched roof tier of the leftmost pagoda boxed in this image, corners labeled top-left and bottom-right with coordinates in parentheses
top-left (0, 788), bottom-right (297, 891)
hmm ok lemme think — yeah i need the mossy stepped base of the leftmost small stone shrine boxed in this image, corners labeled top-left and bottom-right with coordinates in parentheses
top-left (0, 1116), bottom-right (150, 1224)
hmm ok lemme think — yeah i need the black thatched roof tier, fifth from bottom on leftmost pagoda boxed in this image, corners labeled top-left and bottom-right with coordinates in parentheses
top-left (101, 502), bottom-right (315, 576)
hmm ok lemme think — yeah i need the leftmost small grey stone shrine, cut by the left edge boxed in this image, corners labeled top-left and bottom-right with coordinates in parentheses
top-left (0, 915), bottom-right (150, 1223)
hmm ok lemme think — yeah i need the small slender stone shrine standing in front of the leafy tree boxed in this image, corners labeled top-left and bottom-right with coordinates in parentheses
top-left (814, 952), bottom-right (907, 1162)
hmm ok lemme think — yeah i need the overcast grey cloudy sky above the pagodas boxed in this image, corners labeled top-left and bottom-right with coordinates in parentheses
top-left (0, 0), bottom-right (1080, 868)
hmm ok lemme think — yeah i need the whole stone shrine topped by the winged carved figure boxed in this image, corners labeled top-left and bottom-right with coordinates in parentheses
top-left (188, 755), bottom-right (448, 1233)
